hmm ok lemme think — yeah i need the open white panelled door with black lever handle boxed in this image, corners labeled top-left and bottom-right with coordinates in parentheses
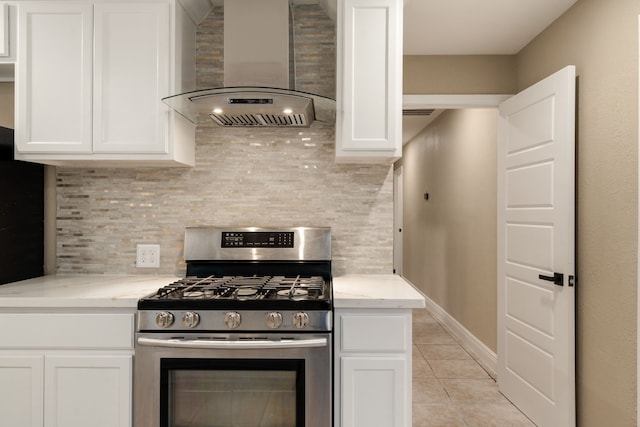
top-left (498, 66), bottom-right (575, 427)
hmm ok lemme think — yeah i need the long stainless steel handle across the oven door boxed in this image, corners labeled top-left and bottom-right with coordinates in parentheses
top-left (138, 337), bottom-right (328, 349)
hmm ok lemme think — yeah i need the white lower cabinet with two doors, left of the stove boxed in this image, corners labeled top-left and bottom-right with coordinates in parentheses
top-left (0, 313), bottom-right (133, 427)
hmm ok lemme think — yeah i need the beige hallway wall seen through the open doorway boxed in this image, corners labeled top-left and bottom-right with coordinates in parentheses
top-left (402, 109), bottom-right (497, 351)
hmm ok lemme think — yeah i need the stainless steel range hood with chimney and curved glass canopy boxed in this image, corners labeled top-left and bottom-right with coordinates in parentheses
top-left (162, 0), bottom-right (335, 127)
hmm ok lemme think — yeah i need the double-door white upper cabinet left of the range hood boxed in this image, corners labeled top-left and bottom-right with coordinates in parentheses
top-left (16, 0), bottom-right (195, 166)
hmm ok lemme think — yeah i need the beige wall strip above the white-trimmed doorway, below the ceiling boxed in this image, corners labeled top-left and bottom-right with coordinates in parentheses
top-left (403, 55), bottom-right (516, 95)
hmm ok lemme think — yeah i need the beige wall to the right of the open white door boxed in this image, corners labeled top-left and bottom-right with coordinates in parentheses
top-left (517, 0), bottom-right (640, 427)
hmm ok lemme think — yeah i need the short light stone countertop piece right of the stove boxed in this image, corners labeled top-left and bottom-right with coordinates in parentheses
top-left (333, 274), bottom-right (425, 308)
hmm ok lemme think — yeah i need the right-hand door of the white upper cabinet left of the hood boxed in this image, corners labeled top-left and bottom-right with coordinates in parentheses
top-left (93, 2), bottom-right (170, 153)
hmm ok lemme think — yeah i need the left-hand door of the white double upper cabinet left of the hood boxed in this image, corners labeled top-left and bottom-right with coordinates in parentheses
top-left (16, 2), bottom-right (93, 153)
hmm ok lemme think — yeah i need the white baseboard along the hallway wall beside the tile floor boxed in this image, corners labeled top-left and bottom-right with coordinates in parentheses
top-left (424, 288), bottom-right (498, 379)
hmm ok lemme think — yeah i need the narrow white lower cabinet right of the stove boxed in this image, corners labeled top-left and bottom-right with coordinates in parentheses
top-left (334, 309), bottom-right (411, 427)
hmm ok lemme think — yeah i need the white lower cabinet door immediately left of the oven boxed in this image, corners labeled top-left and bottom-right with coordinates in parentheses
top-left (44, 355), bottom-right (132, 427)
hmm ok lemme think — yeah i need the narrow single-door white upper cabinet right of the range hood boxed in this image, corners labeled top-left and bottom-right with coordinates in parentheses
top-left (336, 0), bottom-right (402, 162)
